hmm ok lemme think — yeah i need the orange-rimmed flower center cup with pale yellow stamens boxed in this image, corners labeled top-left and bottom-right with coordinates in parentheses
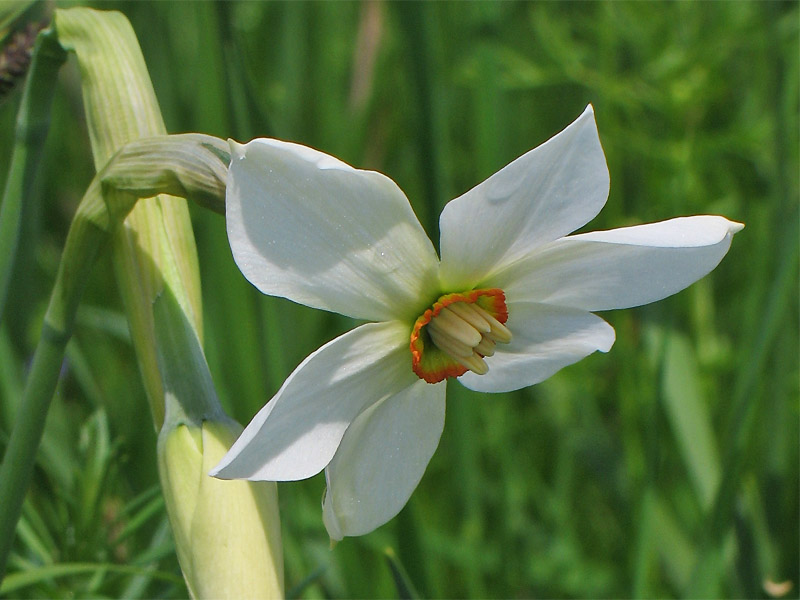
top-left (410, 288), bottom-right (511, 383)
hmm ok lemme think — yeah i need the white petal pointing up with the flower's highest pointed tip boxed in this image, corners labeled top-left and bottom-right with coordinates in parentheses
top-left (439, 106), bottom-right (609, 290)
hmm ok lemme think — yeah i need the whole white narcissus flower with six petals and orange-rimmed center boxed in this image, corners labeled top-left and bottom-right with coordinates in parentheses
top-left (212, 106), bottom-right (743, 540)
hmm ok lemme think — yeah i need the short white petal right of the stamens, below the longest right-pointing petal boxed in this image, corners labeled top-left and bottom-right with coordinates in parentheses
top-left (458, 302), bottom-right (614, 392)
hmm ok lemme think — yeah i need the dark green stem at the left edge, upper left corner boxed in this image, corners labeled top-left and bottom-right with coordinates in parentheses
top-left (0, 30), bottom-right (66, 318)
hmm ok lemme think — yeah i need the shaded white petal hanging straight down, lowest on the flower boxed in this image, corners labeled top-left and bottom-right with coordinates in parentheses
top-left (322, 380), bottom-right (447, 540)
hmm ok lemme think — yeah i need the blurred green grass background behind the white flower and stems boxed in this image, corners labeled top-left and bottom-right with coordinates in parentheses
top-left (0, 2), bottom-right (800, 598)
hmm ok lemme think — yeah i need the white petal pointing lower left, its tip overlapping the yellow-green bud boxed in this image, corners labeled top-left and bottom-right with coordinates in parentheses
top-left (211, 322), bottom-right (417, 481)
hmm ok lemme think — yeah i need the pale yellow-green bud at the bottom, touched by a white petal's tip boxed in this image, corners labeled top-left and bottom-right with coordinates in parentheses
top-left (158, 418), bottom-right (283, 599)
